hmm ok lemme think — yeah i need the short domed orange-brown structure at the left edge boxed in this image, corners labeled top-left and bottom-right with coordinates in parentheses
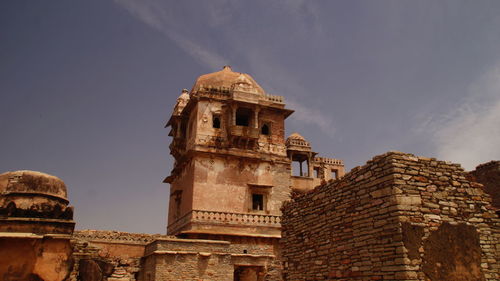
top-left (0, 171), bottom-right (75, 281)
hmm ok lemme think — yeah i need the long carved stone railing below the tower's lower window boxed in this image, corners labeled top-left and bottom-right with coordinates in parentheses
top-left (168, 210), bottom-right (281, 234)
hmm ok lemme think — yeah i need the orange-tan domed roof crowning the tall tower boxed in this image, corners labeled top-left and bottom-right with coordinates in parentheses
top-left (192, 65), bottom-right (265, 95)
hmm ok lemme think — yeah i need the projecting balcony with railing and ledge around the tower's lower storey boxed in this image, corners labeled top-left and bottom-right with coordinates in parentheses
top-left (167, 210), bottom-right (281, 235)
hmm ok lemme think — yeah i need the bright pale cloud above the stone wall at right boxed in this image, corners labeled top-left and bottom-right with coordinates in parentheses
top-left (420, 64), bottom-right (500, 170)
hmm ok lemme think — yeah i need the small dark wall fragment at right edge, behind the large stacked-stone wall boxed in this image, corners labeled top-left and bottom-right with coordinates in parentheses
top-left (470, 161), bottom-right (500, 211)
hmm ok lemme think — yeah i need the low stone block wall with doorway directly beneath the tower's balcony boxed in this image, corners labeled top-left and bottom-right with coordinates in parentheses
top-left (140, 238), bottom-right (281, 281)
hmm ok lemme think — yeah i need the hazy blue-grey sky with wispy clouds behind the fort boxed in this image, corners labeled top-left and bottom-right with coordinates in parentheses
top-left (0, 0), bottom-right (500, 233)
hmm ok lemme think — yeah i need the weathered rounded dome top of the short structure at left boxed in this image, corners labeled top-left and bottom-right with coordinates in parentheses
top-left (0, 170), bottom-right (68, 201)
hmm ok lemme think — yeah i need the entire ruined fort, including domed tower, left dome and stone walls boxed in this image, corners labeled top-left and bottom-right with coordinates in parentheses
top-left (0, 66), bottom-right (500, 281)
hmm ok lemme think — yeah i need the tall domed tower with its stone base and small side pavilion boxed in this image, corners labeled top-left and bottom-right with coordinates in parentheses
top-left (139, 66), bottom-right (344, 280)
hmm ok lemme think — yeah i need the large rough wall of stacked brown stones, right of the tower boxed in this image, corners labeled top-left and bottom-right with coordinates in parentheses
top-left (282, 152), bottom-right (500, 281)
